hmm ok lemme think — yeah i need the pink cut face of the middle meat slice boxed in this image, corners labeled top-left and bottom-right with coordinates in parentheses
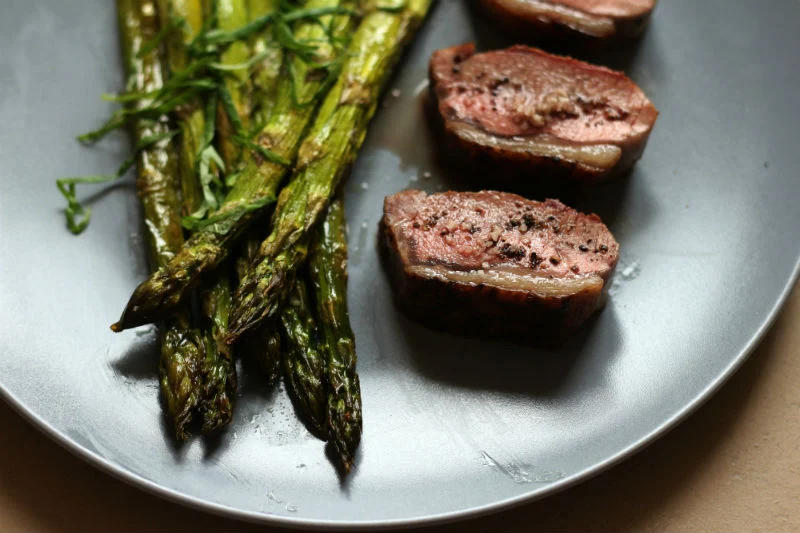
top-left (437, 50), bottom-right (649, 143)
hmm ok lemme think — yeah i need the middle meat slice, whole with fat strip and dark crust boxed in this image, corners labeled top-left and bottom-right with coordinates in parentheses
top-left (430, 44), bottom-right (658, 185)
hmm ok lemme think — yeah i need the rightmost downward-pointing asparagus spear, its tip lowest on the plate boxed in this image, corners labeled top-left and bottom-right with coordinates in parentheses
top-left (309, 200), bottom-right (362, 472)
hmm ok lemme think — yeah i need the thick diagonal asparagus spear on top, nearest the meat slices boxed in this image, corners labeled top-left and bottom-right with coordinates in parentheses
top-left (228, 0), bottom-right (432, 342)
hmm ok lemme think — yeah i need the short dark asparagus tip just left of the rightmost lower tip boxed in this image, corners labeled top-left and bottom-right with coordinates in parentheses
top-left (281, 277), bottom-right (328, 440)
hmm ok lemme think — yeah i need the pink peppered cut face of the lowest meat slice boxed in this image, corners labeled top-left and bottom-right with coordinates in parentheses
top-left (402, 193), bottom-right (617, 278)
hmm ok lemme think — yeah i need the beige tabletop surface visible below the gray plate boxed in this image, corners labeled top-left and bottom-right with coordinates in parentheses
top-left (0, 282), bottom-right (800, 532)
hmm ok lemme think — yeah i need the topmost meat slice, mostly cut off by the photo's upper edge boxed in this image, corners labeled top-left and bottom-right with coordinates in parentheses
top-left (480, 0), bottom-right (656, 39)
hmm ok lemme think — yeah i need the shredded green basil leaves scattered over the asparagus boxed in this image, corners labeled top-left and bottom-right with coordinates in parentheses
top-left (62, 0), bottom-right (360, 234)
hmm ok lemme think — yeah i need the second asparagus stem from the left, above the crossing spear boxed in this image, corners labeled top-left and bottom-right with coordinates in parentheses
top-left (157, 0), bottom-right (205, 215)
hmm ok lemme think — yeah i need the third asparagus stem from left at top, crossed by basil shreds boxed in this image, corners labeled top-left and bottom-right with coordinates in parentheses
top-left (213, 0), bottom-right (250, 166)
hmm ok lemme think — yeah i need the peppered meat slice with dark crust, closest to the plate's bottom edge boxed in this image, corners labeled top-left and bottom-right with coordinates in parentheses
top-left (381, 190), bottom-right (619, 341)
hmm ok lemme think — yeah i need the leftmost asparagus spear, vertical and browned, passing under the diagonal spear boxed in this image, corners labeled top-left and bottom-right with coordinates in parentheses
top-left (117, 0), bottom-right (204, 440)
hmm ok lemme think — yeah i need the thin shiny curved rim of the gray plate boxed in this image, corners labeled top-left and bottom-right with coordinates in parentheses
top-left (0, 253), bottom-right (800, 530)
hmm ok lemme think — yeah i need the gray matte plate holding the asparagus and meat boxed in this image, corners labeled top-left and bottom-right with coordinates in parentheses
top-left (0, 0), bottom-right (800, 526)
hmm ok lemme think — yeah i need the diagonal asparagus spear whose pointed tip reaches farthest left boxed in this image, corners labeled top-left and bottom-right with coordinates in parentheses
top-left (112, 0), bottom-right (354, 331)
